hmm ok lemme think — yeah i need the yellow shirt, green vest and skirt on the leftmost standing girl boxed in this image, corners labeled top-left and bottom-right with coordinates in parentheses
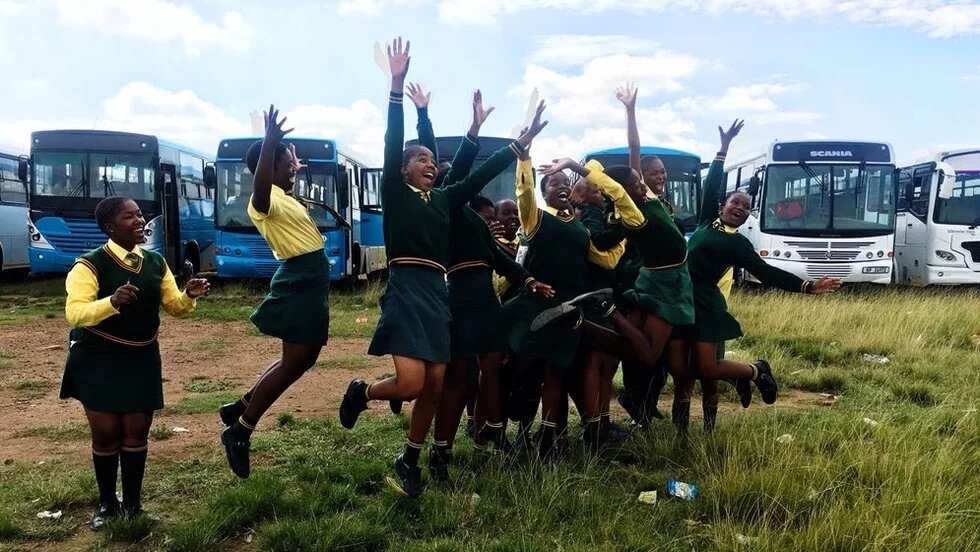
top-left (60, 240), bottom-right (197, 413)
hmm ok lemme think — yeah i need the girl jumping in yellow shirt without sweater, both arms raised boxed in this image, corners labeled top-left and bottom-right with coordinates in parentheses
top-left (219, 105), bottom-right (330, 478)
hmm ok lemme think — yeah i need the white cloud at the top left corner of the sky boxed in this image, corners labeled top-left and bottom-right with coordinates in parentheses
top-left (57, 0), bottom-right (252, 54)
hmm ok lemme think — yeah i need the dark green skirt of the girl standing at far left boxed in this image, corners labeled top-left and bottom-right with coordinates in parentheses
top-left (60, 328), bottom-right (163, 413)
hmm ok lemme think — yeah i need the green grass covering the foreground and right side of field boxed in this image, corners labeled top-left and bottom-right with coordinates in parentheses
top-left (0, 282), bottom-right (980, 552)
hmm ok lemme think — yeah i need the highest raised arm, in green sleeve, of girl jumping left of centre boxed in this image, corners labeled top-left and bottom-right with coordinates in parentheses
top-left (381, 37), bottom-right (412, 208)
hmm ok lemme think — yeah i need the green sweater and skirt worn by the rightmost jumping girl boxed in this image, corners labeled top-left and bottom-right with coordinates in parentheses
top-left (674, 154), bottom-right (811, 342)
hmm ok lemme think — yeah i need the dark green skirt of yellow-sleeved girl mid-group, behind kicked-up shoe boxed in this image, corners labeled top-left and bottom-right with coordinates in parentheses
top-left (503, 291), bottom-right (581, 368)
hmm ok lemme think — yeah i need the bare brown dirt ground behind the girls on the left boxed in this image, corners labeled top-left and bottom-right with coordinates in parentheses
top-left (0, 317), bottom-right (822, 463)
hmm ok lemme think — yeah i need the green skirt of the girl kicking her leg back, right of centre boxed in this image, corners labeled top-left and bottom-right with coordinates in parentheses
top-left (623, 263), bottom-right (694, 326)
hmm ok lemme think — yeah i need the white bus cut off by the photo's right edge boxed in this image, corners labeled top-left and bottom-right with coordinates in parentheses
top-left (895, 149), bottom-right (980, 286)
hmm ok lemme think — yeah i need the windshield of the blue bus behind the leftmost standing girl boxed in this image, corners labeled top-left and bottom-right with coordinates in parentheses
top-left (32, 152), bottom-right (156, 201)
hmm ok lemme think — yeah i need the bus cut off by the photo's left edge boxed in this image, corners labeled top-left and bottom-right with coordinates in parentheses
top-left (0, 152), bottom-right (30, 271)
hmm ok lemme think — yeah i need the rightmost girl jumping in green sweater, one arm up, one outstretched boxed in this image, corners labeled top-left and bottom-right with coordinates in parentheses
top-left (667, 120), bottom-right (841, 432)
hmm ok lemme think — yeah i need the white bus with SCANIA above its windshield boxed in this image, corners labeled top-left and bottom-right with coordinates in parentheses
top-left (725, 140), bottom-right (897, 284)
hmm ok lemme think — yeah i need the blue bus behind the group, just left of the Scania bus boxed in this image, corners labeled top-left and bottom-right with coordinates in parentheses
top-left (583, 146), bottom-right (701, 237)
